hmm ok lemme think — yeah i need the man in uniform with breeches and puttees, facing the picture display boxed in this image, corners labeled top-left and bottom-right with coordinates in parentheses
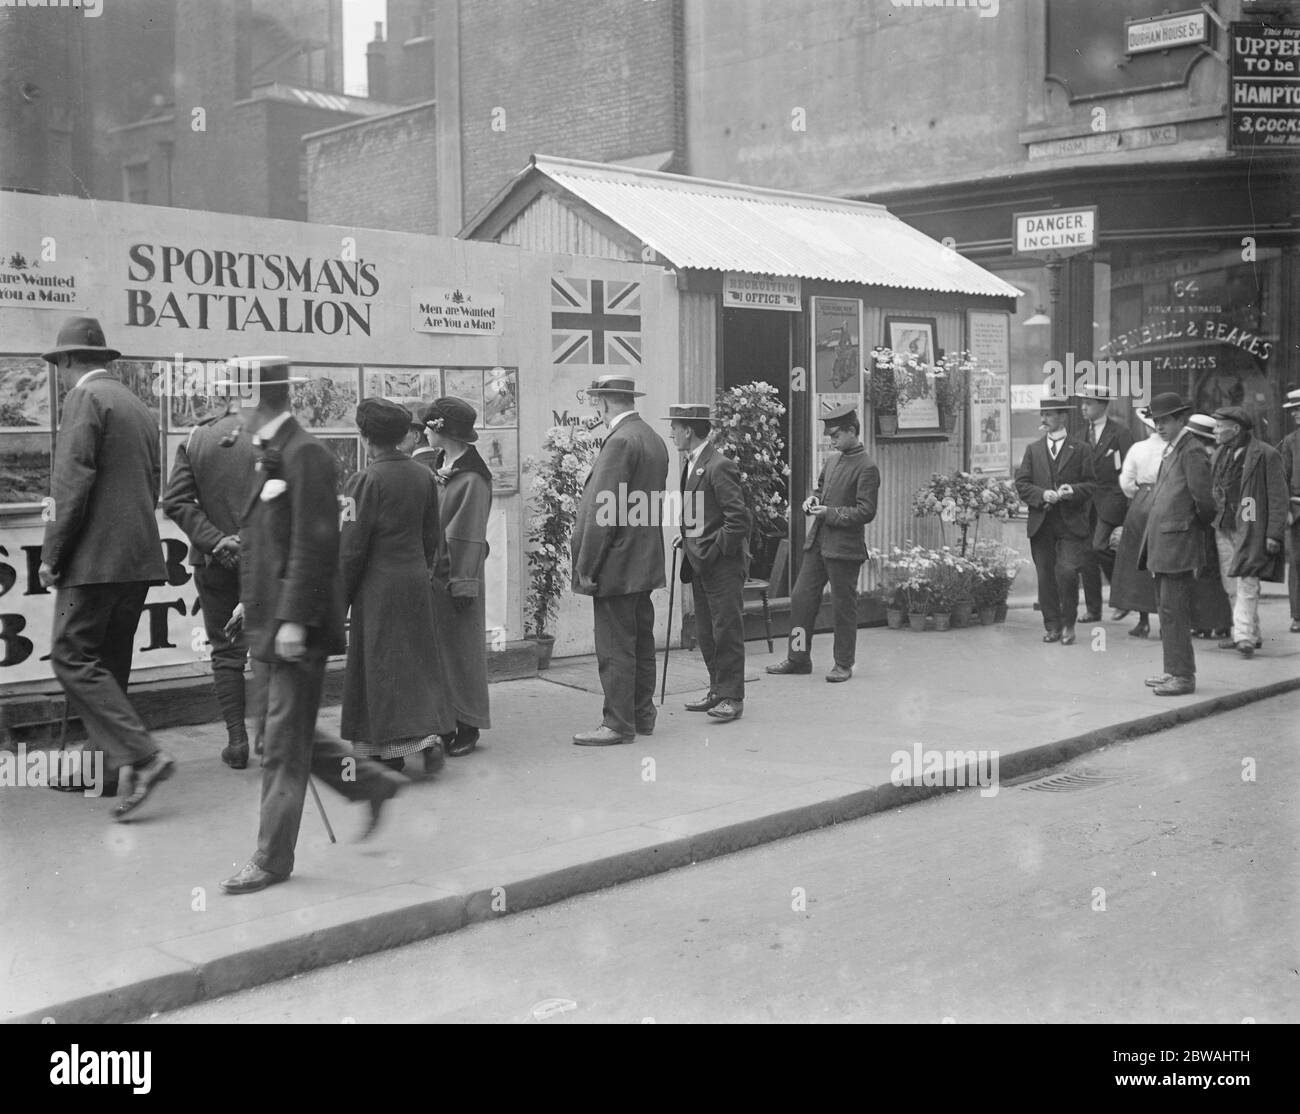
top-left (163, 380), bottom-right (256, 770)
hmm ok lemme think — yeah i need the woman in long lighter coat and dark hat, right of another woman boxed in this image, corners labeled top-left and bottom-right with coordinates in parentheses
top-left (420, 398), bottom-right (491, 757)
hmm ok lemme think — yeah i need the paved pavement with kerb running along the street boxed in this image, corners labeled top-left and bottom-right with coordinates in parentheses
top-left (0, 595), bottom-right (1300, 1023)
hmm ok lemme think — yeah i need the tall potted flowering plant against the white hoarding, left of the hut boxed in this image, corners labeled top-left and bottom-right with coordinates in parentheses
top-left (524, 422), bottom-right (601, 660)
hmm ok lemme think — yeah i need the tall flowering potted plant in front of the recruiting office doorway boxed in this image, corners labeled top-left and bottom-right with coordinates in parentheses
top-left (712, 381), bottom-right (790, 577)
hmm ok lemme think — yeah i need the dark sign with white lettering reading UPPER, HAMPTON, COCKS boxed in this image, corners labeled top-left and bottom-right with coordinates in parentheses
top-left (1229, 23), bottom-right (1300, 151)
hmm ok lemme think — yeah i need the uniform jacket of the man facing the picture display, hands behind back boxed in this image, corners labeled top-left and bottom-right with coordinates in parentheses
top-left (163, 412), bottom-right (257, 565)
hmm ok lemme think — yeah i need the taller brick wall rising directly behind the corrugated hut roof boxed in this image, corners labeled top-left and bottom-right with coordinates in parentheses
top-left (451, 0), bottom-right (685, 219)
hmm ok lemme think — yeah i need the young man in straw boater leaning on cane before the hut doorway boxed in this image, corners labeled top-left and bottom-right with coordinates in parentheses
top-left (668, 403), bottom-right (751, 723)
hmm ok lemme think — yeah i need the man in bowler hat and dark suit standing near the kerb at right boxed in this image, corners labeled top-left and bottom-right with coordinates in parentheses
top-left (1138, 394), bottom-right (1214, 697)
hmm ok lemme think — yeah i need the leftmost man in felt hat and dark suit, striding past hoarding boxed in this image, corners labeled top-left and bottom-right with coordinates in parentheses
top-left (39, 317), bottom-right (176, 820)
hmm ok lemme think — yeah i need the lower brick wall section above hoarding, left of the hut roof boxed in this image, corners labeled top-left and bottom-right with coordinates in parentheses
top-left (306, 104), bottom-right (441, 234)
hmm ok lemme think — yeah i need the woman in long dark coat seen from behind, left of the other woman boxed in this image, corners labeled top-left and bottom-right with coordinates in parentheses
top-left (339, 398), bottom-right (455, 775)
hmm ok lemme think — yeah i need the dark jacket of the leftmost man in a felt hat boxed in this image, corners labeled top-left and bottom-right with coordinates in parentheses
top-left (40, 373), bottom-right (166, 588)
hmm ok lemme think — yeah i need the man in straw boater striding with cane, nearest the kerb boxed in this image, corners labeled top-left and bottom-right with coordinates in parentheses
top-left (221, 356), bottom-right (404, 893)
